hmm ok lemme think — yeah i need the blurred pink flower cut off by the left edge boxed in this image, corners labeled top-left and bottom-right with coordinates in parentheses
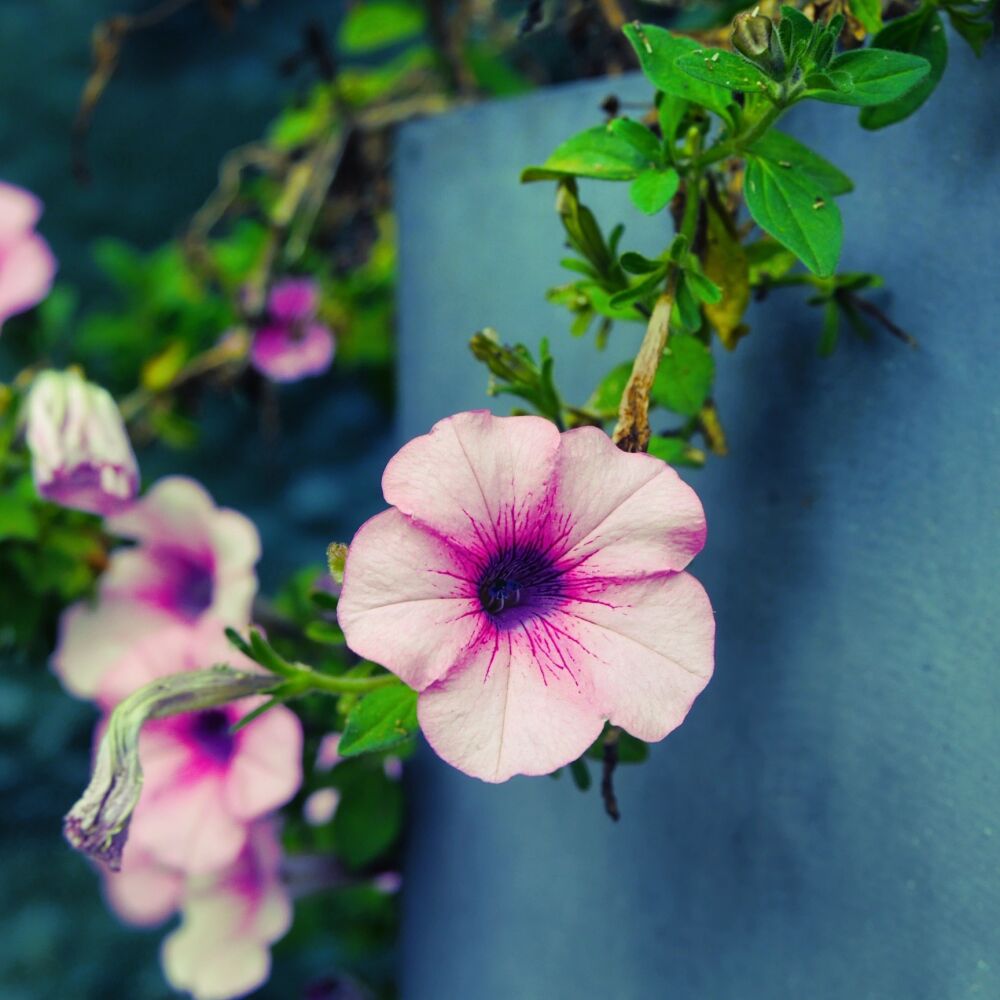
top-left (0, 181), bottom-right (56, 326)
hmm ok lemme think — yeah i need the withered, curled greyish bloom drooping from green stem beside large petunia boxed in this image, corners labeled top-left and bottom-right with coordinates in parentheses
top-left (63, 667), bottom-right (277, 871)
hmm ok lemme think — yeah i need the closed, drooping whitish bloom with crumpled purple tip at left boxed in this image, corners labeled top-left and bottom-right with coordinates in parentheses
top-left (26, 370), bottom-right (139, 515)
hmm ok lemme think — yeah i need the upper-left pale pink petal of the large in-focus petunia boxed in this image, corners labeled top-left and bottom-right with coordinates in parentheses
top-left (382, 410), bottom-right (559, 552)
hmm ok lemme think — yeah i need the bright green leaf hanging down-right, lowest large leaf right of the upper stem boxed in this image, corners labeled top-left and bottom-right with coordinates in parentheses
top-left (745, 157), bottom-right (844, 278)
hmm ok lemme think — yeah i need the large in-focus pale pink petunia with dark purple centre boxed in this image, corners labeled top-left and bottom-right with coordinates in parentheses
top-left (338, 412), bottom-right (715, 781)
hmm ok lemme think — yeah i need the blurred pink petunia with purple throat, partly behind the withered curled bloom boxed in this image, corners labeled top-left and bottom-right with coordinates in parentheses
top-left (98, 618), bottom-right (302, 874)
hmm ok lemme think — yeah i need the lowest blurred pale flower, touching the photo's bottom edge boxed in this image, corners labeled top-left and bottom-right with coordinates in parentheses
top-left (161, 822), bottom-right (292, 1000)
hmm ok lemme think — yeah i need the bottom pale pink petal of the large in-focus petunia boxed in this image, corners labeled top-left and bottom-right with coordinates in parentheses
top-left (417, 621), bottom-right (604, 781)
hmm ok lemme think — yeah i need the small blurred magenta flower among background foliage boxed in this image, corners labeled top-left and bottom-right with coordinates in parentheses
top-left (250, 278), bottom-right (334, 382)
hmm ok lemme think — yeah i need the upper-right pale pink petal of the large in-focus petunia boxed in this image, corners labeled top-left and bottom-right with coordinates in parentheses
top-left (553, 427), bottom-right (705, 577)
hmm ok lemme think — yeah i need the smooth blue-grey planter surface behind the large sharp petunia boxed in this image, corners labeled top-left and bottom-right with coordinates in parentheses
top-left (398, 31), bottom-right (1000, 1000)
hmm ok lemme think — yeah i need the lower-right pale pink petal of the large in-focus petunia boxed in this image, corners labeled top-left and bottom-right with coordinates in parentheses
top-left (553, 573), bottom-right (715, 742)
